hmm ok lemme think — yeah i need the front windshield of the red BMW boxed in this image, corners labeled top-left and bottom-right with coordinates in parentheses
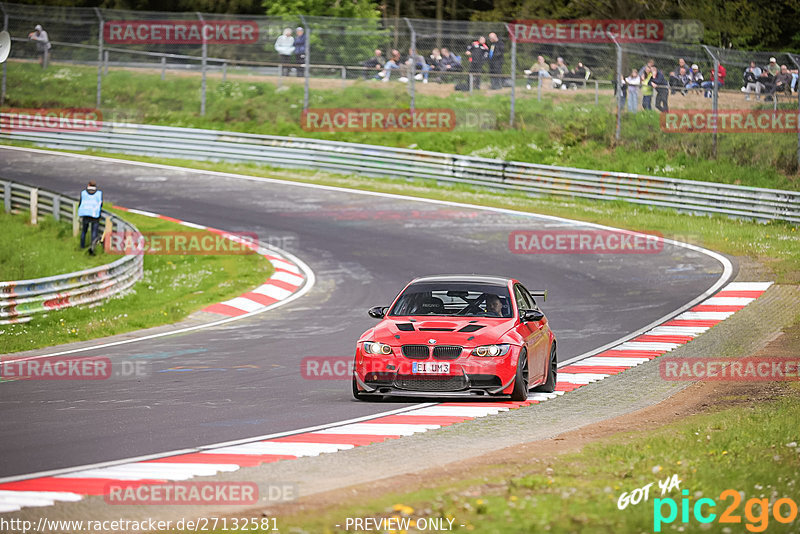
top-left (389, 282), bottom-right (513, 318)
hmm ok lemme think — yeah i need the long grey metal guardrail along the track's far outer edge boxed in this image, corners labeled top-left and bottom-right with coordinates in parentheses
top-left (0, 119), bottom-right (800, 223)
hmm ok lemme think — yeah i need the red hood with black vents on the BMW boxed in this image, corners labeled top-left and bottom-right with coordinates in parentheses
top-left (362, 316), bottom-right (514, 346)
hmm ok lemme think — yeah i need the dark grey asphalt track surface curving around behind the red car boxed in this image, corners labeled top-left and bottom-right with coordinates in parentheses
top-left (0, 149), bottom-right (723, 477)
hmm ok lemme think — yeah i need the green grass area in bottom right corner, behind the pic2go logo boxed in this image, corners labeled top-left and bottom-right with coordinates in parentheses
top-left (280, 384), bottom-right (800, 534)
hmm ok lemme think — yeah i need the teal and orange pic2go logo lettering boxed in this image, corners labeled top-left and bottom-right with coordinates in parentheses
top-left (653, 489), bottom-right (797, 532)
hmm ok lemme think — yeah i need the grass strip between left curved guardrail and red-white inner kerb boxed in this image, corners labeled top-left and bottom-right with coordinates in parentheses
top-left (0, 208), bottom-right (273, 354)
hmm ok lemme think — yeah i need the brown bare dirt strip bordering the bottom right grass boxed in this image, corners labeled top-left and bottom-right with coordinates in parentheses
top-left (259, 322), bottom-right (800, 518)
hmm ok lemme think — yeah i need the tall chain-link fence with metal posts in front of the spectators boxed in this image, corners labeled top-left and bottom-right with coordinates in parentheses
top-left (0, 3), bottom-right (800, 168)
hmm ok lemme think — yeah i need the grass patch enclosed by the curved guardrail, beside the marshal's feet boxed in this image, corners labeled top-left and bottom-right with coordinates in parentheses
top-left (0, 212), bottom-right (112, 281)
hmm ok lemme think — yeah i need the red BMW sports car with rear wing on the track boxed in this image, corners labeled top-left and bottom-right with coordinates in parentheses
top-left (353, 275), bottom-right (557, 400)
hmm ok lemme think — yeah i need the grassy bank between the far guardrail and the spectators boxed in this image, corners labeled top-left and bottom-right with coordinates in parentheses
top-left (7, 62), bottom-right (800, 190)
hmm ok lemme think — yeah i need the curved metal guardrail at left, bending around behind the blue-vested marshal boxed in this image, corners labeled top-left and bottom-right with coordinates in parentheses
top-left (0, 179), bottom-right (143, 324)
